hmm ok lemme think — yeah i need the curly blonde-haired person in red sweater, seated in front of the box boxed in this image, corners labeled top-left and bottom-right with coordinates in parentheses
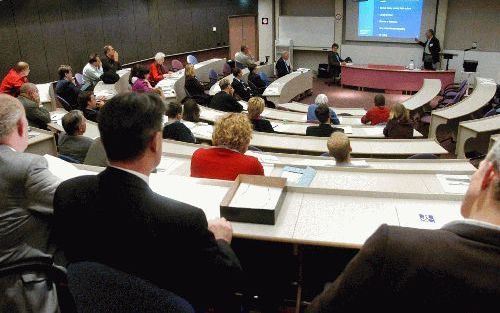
top-left (191, 113), bottom-right (264, 180)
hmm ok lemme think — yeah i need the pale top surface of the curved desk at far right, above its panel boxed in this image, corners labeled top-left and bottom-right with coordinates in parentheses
top-left (432, 77), bottom-right (497, 120)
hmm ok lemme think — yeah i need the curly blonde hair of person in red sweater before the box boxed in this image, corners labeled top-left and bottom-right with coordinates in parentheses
top-left (212, 113), bottom-right (252, 153)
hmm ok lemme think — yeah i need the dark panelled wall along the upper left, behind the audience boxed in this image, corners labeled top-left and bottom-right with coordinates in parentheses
top-left (0, 0), bottom-right (257, 83)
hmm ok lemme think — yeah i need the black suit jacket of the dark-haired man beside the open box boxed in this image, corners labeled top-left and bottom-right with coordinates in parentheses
top-left (54, 168), bottom-right (241, 304)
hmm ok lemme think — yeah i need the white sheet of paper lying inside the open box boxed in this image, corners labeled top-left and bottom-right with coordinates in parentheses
top-left (229, 183), bottom-right (283, 210)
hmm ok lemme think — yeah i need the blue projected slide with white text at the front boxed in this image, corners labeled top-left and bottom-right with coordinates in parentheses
top-left (358, 0), bottom-right (424, 39)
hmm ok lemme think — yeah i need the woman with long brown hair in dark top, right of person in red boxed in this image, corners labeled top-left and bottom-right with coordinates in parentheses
top-left (384, 103), bottom-right (413, 139)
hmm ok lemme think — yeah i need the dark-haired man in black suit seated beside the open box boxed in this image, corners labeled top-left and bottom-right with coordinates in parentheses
top-left (54, 93), bottom-right (241, 312)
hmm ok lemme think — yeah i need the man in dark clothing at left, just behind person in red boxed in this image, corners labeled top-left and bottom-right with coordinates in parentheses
top-left (17, 83), bottom-right (50, 129)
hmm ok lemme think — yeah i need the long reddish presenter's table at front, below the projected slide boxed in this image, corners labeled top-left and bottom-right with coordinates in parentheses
top-left (341, 64), bottom-right (455, 92)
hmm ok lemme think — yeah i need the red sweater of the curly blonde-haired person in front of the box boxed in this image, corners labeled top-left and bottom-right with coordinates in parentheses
top-left (191, 148), bottom-right (264, 180)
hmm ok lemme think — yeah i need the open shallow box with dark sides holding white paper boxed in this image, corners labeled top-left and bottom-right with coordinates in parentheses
top-left (220, 175), bottom-right (286, 225)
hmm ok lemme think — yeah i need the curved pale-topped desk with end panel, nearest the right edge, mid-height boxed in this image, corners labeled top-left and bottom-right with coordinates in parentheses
top-left (429, 77), bottom-right (497, 138)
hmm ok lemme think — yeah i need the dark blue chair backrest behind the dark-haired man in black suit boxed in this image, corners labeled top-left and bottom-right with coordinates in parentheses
top-left (68, 262), bottom-right (194, 313)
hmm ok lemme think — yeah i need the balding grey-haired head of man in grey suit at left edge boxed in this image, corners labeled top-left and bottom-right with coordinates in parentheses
top-left (0, 94), bottom-right (28, 151)
